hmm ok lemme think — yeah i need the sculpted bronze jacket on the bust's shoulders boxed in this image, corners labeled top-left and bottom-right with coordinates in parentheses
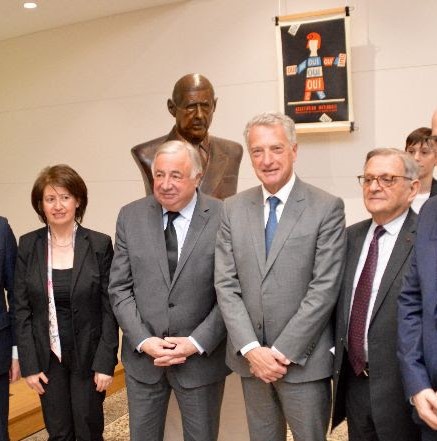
top-left (131, 127), bottom-right (243, 200)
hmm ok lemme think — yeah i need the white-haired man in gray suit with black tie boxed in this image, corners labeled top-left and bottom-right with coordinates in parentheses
top-left (109, 141), bottom-right (229, 441)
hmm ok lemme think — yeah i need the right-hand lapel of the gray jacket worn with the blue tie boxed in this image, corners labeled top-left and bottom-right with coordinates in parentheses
top-left (264, 177), bottom-right (306, 275)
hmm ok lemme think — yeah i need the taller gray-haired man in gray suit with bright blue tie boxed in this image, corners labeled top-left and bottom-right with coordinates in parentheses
top-left (215, 113), bottom-right (345, 441)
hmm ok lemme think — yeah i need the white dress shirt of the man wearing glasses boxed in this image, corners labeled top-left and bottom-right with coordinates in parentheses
top-left (349, 210), bottom-right (408, 361)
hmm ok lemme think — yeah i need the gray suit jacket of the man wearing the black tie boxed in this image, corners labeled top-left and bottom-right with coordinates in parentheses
top-left (109, 192), bottom-right (229, 388)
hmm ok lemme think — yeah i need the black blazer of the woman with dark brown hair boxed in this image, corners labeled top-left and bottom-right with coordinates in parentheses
top-left (15, 226), bottom-right (118, 377)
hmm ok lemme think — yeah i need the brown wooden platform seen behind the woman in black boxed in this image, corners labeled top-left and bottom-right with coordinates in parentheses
top-left (9, 363), bottom-right (124, 441)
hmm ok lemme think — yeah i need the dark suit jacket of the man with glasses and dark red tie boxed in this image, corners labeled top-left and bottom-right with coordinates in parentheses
top-left (332, 210), bottom-right (418, 441)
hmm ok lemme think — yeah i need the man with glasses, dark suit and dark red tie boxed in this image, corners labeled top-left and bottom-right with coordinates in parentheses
top-left (333, 149), bottom-right (419, 441)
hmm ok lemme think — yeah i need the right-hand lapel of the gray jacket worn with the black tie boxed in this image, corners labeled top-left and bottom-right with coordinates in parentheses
top-left (172, 192), bottom-right (210, 285)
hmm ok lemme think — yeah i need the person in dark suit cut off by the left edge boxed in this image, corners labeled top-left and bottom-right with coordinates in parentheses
top-left (0, 217), bottom-right (20, 441)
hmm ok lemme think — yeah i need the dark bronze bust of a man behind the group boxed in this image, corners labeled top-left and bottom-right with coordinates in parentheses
top-left (132, 74), bottom-right (243, 199)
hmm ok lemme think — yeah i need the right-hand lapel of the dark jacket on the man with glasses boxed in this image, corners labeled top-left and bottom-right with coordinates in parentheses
top-left (370, 210), bottom-right (416, 323)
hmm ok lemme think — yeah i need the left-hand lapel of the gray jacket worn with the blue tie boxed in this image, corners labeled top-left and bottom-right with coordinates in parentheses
top-left (243, 186), bottom-right (266, 274)
